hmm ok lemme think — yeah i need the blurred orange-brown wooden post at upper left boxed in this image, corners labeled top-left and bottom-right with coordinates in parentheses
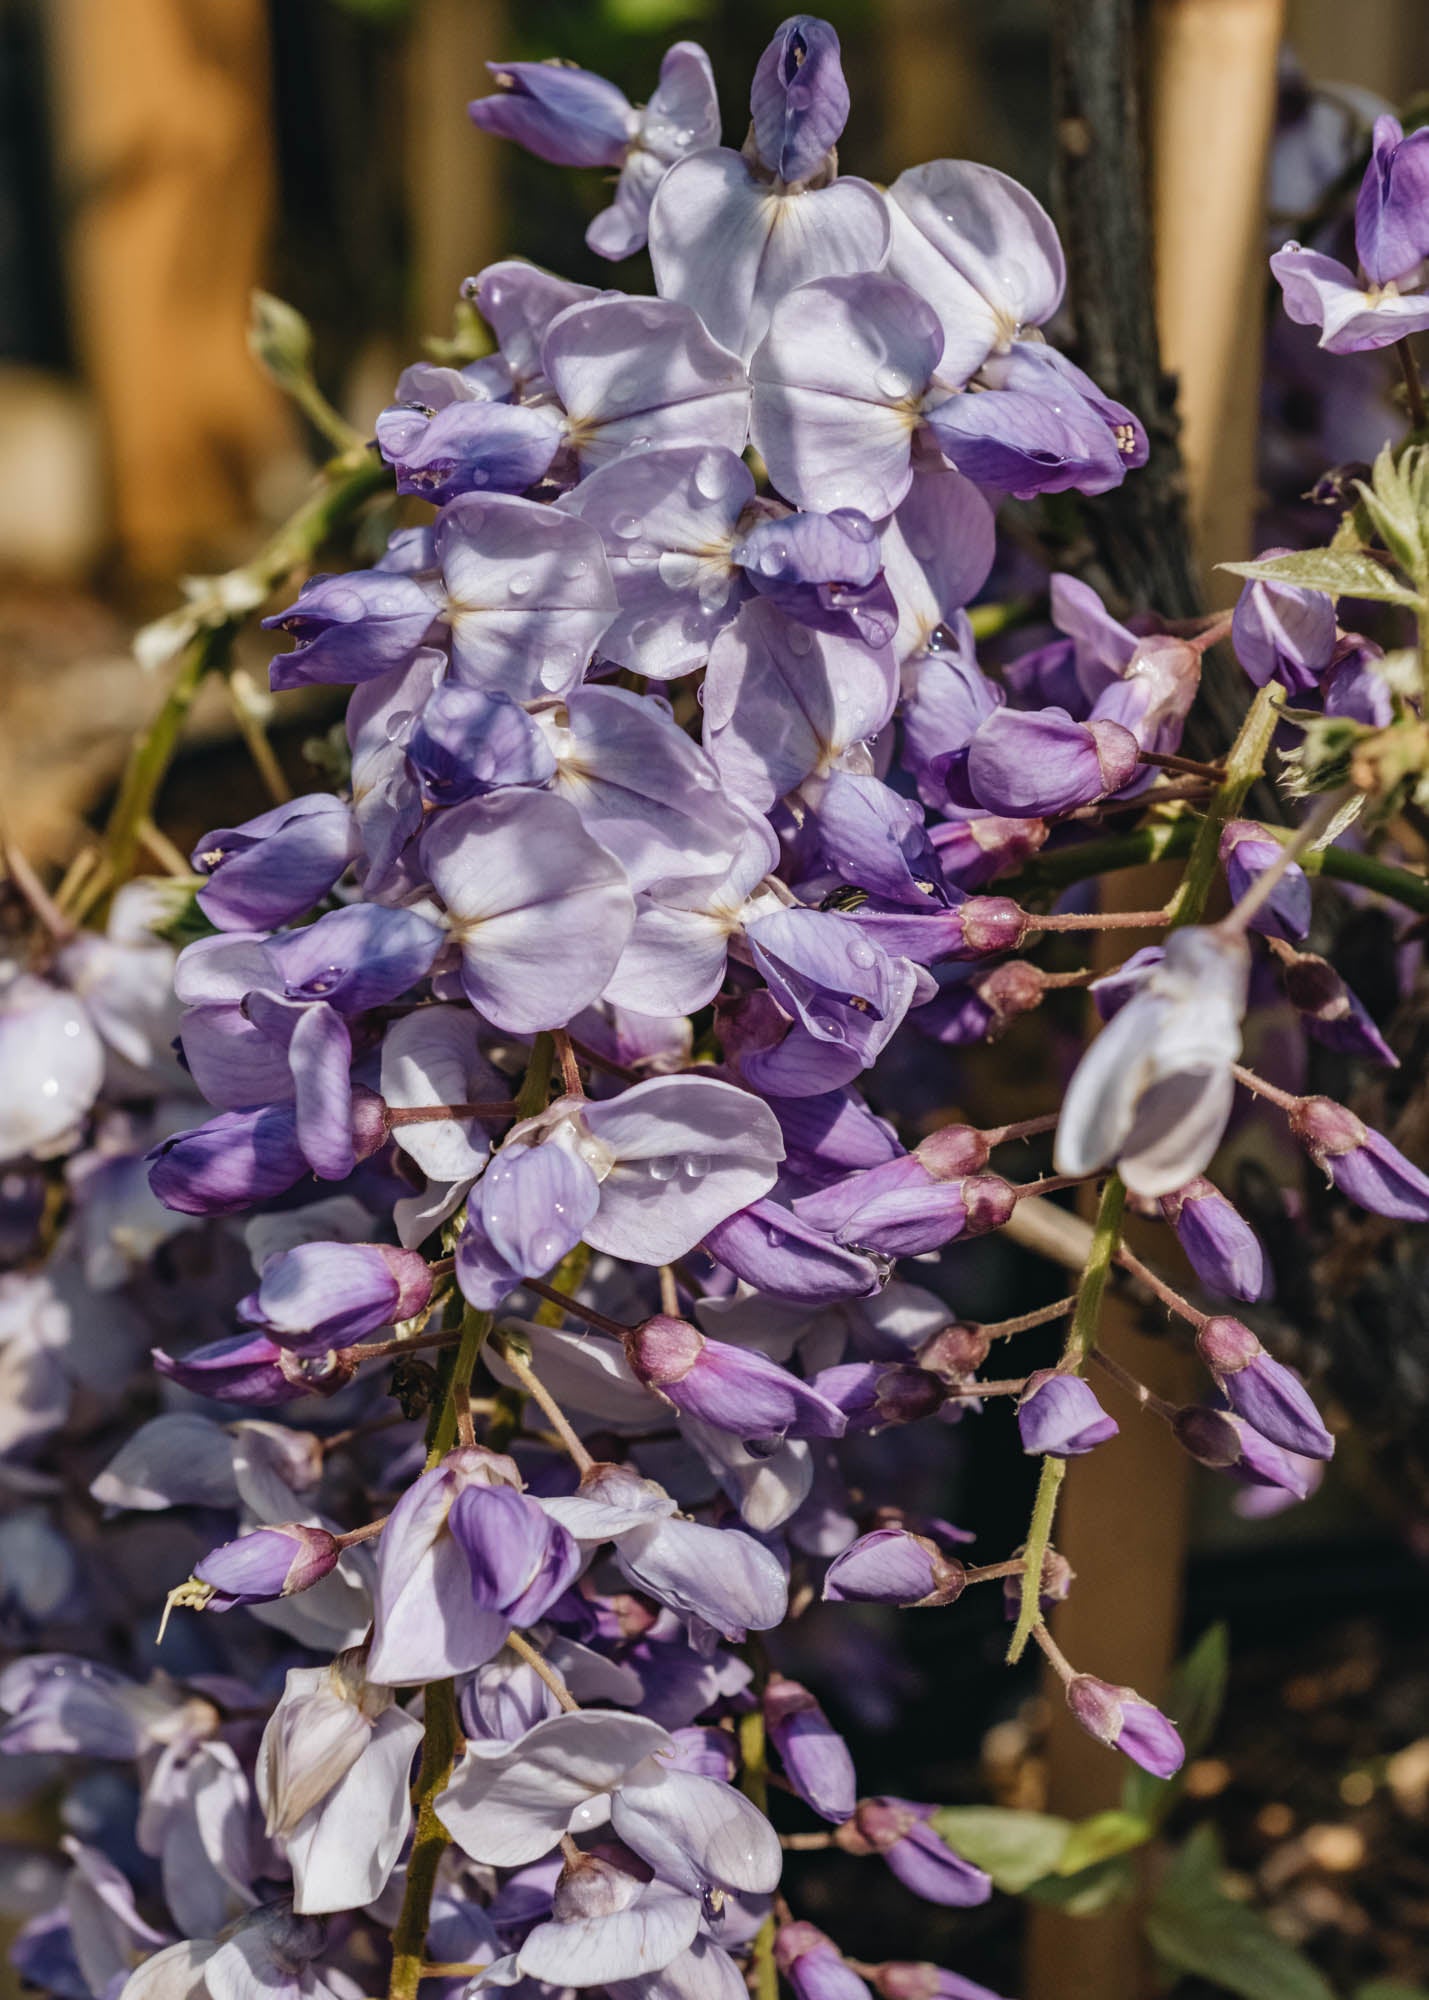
top-left (48, 0), bottom-right (292, 574)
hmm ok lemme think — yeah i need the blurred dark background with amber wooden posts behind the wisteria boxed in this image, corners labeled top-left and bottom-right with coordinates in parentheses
top-left (0, 0), bottom-right (1429, 2000)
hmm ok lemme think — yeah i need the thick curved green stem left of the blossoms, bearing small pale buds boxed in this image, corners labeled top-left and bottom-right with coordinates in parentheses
top-left (104, 448), bottom-right (392, 882)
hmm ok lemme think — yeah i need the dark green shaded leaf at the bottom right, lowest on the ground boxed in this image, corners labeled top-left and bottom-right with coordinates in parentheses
top-left (1147, 1826), bottom-right (1335, 2000)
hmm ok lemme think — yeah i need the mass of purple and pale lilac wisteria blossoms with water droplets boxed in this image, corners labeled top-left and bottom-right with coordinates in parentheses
top-left (0, 16), bottom-right (1429, 2000)
